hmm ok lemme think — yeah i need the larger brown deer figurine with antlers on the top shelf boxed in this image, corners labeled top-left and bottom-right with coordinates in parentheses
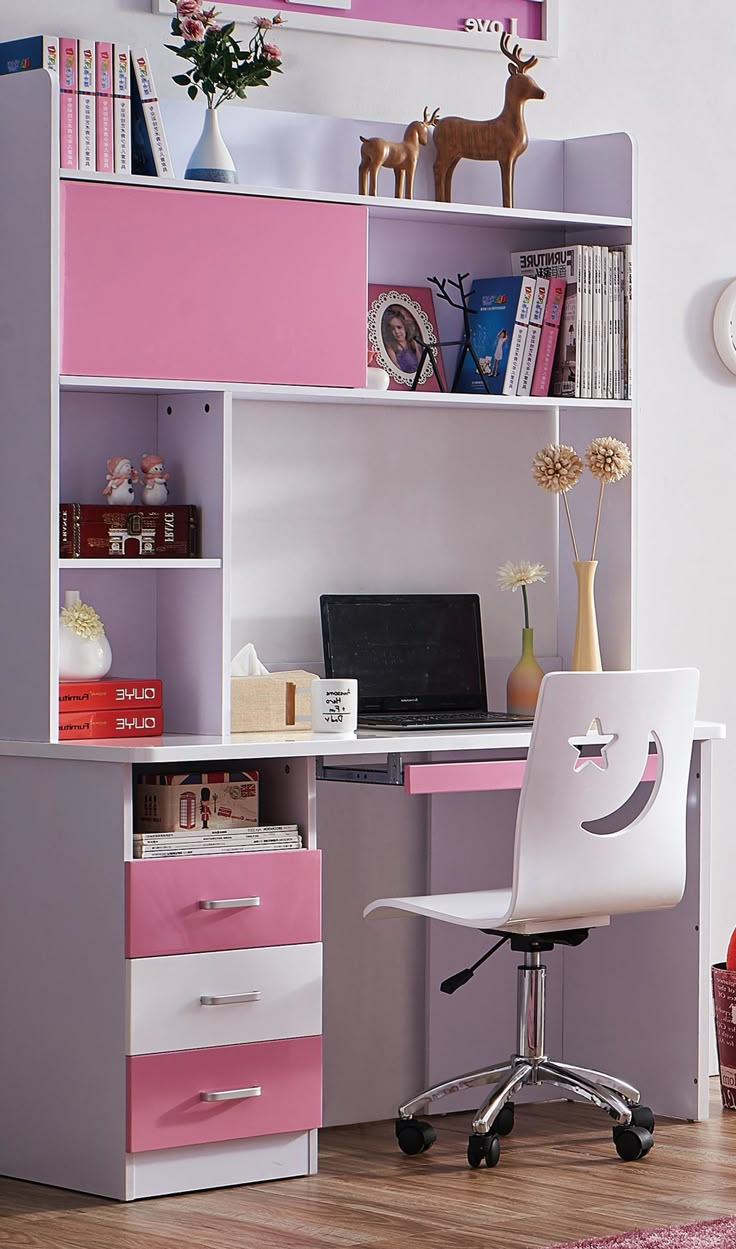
top-left (435, 32), bottom-right (545, 209)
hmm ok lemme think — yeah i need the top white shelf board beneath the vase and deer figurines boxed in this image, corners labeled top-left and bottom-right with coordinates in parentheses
top-left (60, 170), bottom-right (631, 230)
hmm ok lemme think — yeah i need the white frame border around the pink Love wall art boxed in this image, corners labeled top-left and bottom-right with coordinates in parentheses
top-left (151, 0), bottom-right (560, 56)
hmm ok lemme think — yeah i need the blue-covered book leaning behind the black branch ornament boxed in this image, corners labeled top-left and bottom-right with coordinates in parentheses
top-left (455, 276), bottom-right (535, 395)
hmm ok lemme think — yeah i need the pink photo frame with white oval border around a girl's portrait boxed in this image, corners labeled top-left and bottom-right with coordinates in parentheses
top-left (367, 286), bottom-right (446, 391)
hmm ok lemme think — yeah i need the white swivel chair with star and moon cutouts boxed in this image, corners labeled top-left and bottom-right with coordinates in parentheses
top-left (364, 668), bottom-right (699, 1167)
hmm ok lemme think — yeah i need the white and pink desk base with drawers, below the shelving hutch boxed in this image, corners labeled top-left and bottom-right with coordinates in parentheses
top-left (0, 723), bottom-right (724, 1199)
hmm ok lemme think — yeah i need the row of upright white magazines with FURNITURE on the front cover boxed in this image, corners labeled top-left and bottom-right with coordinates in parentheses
top-left (511, 244), bottom-right (632, 400)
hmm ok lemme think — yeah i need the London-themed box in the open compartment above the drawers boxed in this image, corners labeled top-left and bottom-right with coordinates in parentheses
top-left (134, 772), bottom-right (259, 833)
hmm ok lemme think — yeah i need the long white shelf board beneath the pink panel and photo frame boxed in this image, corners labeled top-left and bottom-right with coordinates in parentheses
top-left (60, 377), bottom-right (631, 411)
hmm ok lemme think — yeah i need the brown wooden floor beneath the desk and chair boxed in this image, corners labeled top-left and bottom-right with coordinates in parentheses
top-left (0, 1080), bottom-right (736, 1249)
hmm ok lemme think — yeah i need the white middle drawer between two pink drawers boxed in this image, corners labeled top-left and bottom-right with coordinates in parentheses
top-left (126, 942), bottom-right (322, 1054)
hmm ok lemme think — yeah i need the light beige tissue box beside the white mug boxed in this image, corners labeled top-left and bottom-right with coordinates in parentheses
top-left (230, 668), bottom-right (316, 733)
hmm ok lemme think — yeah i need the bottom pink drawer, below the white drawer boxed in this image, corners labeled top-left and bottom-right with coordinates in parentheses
top-left (126, 1037), bottom-right (322, 1154)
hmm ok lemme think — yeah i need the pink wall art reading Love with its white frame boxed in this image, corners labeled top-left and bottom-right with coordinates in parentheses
top-left (151, 0), bottom-right (560, 56)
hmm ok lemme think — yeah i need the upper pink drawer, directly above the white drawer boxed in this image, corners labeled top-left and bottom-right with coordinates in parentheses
top-left (125, 851), bottom-right (321, 958)
